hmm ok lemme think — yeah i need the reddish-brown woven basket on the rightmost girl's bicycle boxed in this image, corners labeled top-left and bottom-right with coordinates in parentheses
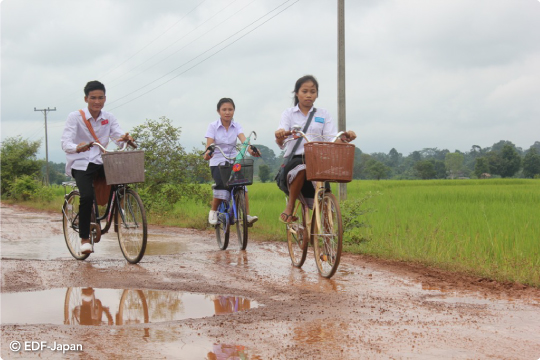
top-left (304, 141), bottom-right (354, 183)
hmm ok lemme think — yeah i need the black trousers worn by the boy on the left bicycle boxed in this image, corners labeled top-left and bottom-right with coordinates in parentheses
top-left (71, 163), bottom-right (105, 239)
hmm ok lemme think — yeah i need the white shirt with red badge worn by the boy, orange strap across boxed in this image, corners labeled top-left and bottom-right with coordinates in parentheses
top-left (60, 108), bottom-right (124, 176)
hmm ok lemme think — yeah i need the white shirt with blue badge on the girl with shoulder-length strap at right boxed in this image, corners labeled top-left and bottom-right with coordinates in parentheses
top-left (277, 105), bottom-right (338, 157)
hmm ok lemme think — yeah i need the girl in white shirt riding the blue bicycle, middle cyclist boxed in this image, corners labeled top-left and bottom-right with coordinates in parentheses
top-left (204, 98), bottom-right (260, 225)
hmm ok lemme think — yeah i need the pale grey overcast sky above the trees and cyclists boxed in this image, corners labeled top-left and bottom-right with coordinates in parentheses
top-left (0, 0), bottom-right (540, 162)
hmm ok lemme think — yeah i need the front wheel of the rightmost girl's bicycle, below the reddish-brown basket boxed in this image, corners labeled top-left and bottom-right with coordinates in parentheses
top-left (311, 193), bottom-right (343, 278)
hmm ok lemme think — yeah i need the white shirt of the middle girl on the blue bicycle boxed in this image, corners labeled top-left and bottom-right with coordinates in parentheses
top-left (204, 119), bottom-right (244, 166)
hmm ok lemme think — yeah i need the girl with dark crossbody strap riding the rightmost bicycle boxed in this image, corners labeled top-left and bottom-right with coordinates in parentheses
top-left (275, 75), bottom-right (356, 223)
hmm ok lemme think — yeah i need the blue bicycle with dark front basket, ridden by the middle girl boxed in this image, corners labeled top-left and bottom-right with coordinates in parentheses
top-left (207, 131), bottom-right (258, 250)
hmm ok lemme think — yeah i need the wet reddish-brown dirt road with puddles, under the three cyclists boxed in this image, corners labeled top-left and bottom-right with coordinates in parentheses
top-left (0, 204), bottom-right (540, 359)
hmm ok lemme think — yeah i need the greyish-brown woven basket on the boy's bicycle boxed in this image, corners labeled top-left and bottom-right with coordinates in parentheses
top-left (101, 150), bottom-right (144, 185)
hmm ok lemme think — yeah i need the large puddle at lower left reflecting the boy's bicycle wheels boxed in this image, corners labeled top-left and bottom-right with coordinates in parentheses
top-left (2, 287), bottom-right (259, 326)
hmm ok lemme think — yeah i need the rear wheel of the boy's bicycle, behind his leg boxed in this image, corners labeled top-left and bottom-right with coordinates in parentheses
top-left (62, 191), bottom-right (90, 260)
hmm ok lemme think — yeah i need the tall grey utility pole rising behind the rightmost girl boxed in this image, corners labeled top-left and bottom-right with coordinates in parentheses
top-left (338, 0), bottom-right (347, 200)
